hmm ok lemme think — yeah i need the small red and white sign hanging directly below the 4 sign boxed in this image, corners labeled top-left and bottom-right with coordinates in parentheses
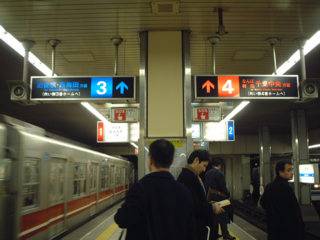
top-left (193, 106), bottom-right (221, 122)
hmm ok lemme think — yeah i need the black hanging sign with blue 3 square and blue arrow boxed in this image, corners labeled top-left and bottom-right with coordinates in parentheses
top-left (30, 77), bottom-right (136, 101)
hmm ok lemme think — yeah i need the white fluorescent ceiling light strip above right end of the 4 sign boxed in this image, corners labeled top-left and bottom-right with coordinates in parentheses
top-left (277, 30), bottom-right (320, 75)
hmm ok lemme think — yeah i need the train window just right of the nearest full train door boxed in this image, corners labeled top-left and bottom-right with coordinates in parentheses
top-left (73, 163), bottom-right (87, 197)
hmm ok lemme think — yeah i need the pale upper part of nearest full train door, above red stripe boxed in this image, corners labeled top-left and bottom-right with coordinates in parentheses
top-left (49, 158), bottom-right (65, 205)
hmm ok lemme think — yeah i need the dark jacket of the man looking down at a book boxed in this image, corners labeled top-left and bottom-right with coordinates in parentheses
top-left (177, 168), bottom-right (214, 240)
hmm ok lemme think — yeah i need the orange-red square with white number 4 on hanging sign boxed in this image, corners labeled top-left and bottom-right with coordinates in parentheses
top-left (218, 76), bottom-right (240, 97)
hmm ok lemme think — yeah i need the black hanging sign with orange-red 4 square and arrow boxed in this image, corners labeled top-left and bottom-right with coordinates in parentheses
top-left (194, 75), bottom-right (299, 100)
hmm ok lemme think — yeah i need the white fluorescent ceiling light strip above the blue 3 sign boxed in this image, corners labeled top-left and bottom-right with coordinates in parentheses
top-left (0, 25), bottom-right (56, 76)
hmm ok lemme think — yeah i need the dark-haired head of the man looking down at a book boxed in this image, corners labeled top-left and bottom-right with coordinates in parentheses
top-left (188, 150), bottom-right (210, 175)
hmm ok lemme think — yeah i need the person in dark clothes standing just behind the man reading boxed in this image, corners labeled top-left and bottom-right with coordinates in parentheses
top-left (205, 158), bottom-right (235, 239)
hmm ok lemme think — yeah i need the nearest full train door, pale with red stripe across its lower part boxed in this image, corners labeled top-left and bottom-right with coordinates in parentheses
top-left (48, 157), bottom-right (67, 237)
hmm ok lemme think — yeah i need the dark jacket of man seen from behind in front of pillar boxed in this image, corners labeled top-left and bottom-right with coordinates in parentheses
top-left (114, 172), bottom-right (195, 240)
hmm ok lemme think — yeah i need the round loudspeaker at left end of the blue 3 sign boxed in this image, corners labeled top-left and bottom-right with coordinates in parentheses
top-left (7, 80), bottom-right (30, 103)
